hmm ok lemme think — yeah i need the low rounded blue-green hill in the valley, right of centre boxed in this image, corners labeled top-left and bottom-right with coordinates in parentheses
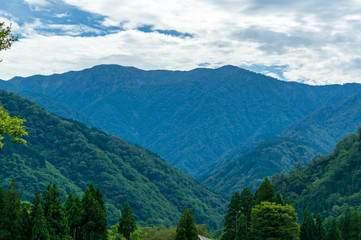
top-left (203, 139), bottom-right (318, 197)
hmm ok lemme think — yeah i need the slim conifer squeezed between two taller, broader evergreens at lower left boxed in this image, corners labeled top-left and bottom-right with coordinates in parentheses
top-left (65, 193), bottom-right (81, 240)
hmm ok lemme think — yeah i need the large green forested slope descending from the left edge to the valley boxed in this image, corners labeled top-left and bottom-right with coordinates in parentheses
top-left (0, 91), bottom-right (226, 229)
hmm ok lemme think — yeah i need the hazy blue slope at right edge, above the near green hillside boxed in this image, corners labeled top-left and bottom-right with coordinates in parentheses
top-left (281, 93), bottom-right (361, 154)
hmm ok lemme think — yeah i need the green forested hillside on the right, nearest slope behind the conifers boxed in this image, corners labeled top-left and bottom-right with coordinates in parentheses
top-left (272, 130), bottom-right (361, 221)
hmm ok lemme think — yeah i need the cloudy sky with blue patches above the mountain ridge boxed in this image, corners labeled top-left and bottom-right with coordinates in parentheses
top-left (0, 0), bottom-right (361, 85)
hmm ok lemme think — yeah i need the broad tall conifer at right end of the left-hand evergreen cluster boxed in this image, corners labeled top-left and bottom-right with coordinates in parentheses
top-left (80, 184), bottom-right (108, 240)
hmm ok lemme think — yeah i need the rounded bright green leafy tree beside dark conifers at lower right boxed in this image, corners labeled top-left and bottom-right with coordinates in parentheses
top-left (251, 202), bottom-right (300, 240)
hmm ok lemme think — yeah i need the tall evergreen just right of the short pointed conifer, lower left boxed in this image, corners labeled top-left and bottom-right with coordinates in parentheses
top-left (43, 183), bottom-right (70, 240)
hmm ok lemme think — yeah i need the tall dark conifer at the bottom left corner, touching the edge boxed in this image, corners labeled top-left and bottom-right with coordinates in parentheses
top-left (0, 178), bottom-right (21, 240)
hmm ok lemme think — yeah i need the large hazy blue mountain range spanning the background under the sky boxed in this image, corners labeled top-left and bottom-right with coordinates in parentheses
top-left (0, 65), bottom-right (361, 177)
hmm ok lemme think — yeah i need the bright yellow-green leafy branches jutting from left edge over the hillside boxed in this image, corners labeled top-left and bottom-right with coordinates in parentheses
top-left (0, 106), bottom-right (28, 148)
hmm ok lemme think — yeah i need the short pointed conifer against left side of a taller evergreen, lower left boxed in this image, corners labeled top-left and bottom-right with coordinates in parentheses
top-left (31, 203), bottom-right (50, 240)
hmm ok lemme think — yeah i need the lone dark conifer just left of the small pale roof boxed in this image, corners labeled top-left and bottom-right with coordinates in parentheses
top-left (175, 207), bottom-right (199, 240)
